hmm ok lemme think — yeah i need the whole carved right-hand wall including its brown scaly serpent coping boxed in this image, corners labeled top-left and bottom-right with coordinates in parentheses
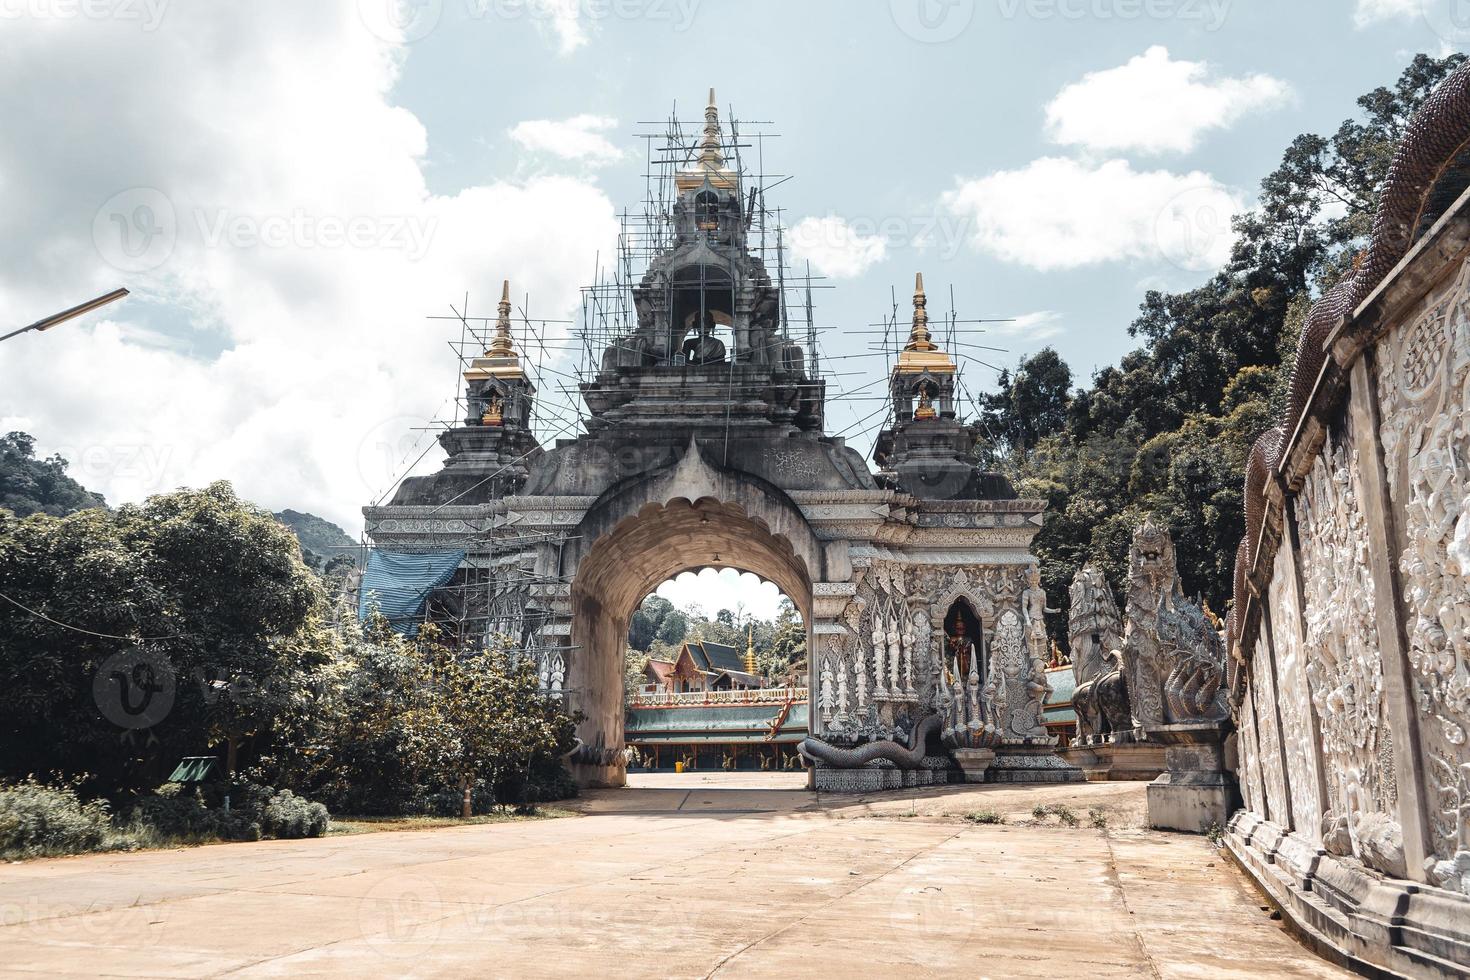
top-left (1227, 66), bottom-right (1470, 934)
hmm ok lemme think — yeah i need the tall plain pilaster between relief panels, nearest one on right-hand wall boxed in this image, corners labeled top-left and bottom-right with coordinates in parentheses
top-left (1348, 354), bottom-right (1430, 882)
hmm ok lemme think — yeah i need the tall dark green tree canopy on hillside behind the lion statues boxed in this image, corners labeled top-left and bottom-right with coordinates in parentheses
top-left (978, 54), bottom-right (1466, 652)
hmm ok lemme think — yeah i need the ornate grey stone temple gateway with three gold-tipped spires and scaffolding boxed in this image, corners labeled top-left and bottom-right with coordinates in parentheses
top-left (363, 93), bottom-right (1082, 789)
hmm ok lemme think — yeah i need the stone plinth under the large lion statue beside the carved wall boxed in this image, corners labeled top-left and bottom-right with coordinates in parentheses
top-left (1148, 721), bottom-right (1236, 833)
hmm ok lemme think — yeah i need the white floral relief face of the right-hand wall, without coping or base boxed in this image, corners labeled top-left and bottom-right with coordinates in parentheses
top-left (1233, 256), bottom-right (1470, 895)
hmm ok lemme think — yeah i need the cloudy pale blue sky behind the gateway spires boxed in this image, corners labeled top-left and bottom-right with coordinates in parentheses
top-left (0, 0), bottom-right (1452, 599)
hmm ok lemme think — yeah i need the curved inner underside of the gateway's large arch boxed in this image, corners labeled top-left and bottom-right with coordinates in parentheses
top-left (567, 497), bottom-right (813, 786)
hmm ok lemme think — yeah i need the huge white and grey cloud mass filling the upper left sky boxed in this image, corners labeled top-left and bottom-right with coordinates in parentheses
top-left (0, 0), bottom-right (616, 532)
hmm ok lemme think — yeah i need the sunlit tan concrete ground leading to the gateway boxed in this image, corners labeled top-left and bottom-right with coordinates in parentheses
top-left (0, 774), bottom-right (1345, 980)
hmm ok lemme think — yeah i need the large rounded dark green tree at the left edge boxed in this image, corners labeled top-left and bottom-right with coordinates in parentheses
top-left (0, 483), bottom-right (329, 795)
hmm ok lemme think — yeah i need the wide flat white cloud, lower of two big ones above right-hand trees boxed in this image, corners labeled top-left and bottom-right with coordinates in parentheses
top-left (942, 157), bottom-right (1245, 270)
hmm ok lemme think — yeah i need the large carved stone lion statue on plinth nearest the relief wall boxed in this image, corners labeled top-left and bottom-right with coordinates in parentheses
top-left (1119, 516), bottom-right (1229, 730)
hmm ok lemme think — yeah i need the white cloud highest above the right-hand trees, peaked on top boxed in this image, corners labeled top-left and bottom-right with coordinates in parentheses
top-left (1047, 45), bottom-right (1287, 153)
